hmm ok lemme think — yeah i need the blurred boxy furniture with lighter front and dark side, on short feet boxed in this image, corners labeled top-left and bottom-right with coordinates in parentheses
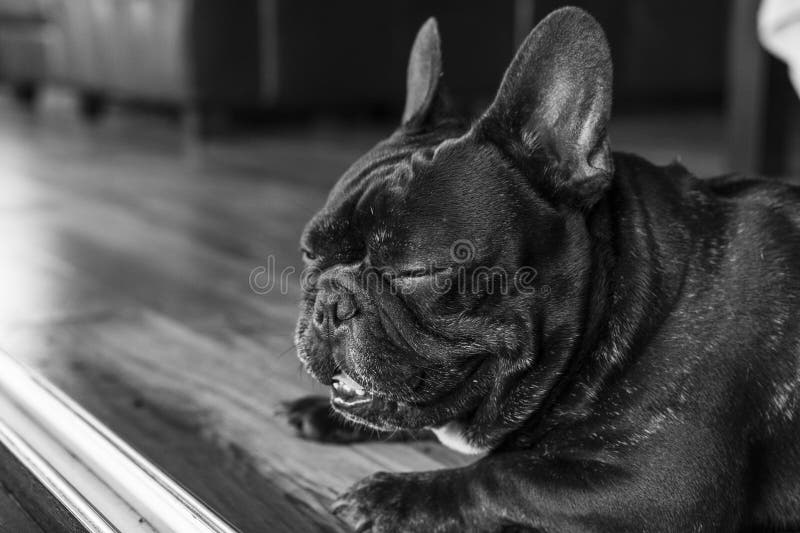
top-left (49, 0), bottom-right (258, 128)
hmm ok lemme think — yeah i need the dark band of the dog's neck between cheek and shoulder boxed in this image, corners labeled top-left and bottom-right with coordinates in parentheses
top-left (526, 154), bottom-right (695, 439)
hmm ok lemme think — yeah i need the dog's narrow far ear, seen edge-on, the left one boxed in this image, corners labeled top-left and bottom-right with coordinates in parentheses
top-left (403, 17), bottom-right (452, 129)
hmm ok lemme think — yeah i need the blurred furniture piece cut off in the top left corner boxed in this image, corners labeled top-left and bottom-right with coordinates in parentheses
top-left (0, 0), bottom-right (51, 106)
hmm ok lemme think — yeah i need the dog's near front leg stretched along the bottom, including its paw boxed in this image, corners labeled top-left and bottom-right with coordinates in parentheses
top-left (333, 446), bottom-right (741, 533)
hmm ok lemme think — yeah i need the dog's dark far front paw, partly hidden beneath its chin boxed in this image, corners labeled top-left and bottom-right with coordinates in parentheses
top-left (278, 396), bottom-right (368, 443)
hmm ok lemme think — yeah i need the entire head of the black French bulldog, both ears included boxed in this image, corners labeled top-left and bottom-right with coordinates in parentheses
top-left (297, 8), bottom-right (612, 445)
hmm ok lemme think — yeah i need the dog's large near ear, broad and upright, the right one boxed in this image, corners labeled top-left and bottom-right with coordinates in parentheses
top-left (477, 7), bottom-right (613, 207)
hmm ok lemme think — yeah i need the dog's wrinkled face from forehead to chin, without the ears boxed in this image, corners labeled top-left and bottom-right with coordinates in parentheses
top-left (298, 130), bottom-right (563, 429)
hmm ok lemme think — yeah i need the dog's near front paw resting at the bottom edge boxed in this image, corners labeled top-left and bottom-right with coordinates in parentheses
top-left (331, 472), bottom-right (467, 533)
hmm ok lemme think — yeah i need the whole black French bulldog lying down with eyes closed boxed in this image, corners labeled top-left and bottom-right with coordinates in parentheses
top-left (290, 8), bottom-right (800, 532)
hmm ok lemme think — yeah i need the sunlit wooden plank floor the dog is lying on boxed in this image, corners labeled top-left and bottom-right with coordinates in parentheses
top-left (0, 93), bottom-right (732, 532)
